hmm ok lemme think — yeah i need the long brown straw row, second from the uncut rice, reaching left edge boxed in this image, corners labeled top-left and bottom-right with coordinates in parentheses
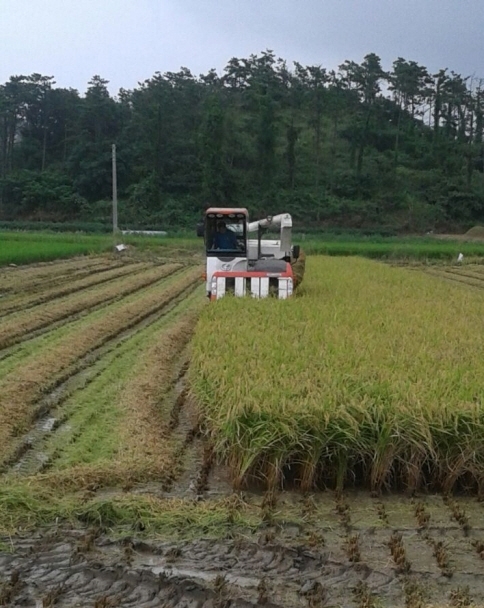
top-left (0, 269), bottom-right (199, 463)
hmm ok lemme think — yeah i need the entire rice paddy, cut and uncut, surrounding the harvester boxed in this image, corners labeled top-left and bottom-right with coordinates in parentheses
top-left (0, 249), bottom-right (484, 608)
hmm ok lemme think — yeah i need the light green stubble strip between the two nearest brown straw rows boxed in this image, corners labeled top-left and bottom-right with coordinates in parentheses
top-left (9, 287), bottom-right (204, 475)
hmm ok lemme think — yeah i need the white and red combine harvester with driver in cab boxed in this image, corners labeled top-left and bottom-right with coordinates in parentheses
top-left (197, 207), bottom-right (304, 300)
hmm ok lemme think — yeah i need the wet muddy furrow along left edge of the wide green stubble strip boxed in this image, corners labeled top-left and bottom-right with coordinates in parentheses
top-left (3, 286), bottom-right (202, 475)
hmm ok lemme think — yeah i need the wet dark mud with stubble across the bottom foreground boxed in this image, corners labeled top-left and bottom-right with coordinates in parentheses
top-left (0, 495), bottom-right (484, 608)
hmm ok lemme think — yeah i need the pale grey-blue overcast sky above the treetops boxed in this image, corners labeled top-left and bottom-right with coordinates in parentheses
top-left (0, 0), bottom-right (484, 94)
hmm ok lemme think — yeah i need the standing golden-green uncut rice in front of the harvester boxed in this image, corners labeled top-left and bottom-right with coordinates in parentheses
top-left (190, 257), bottom-right (484, 491)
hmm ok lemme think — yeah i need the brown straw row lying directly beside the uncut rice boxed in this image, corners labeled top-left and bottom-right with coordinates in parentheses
top-left (37, 298), bottom-right (203, 490)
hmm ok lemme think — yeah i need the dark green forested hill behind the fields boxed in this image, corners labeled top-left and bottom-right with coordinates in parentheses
top-left (0, 50), bottom-right (484, 233)
